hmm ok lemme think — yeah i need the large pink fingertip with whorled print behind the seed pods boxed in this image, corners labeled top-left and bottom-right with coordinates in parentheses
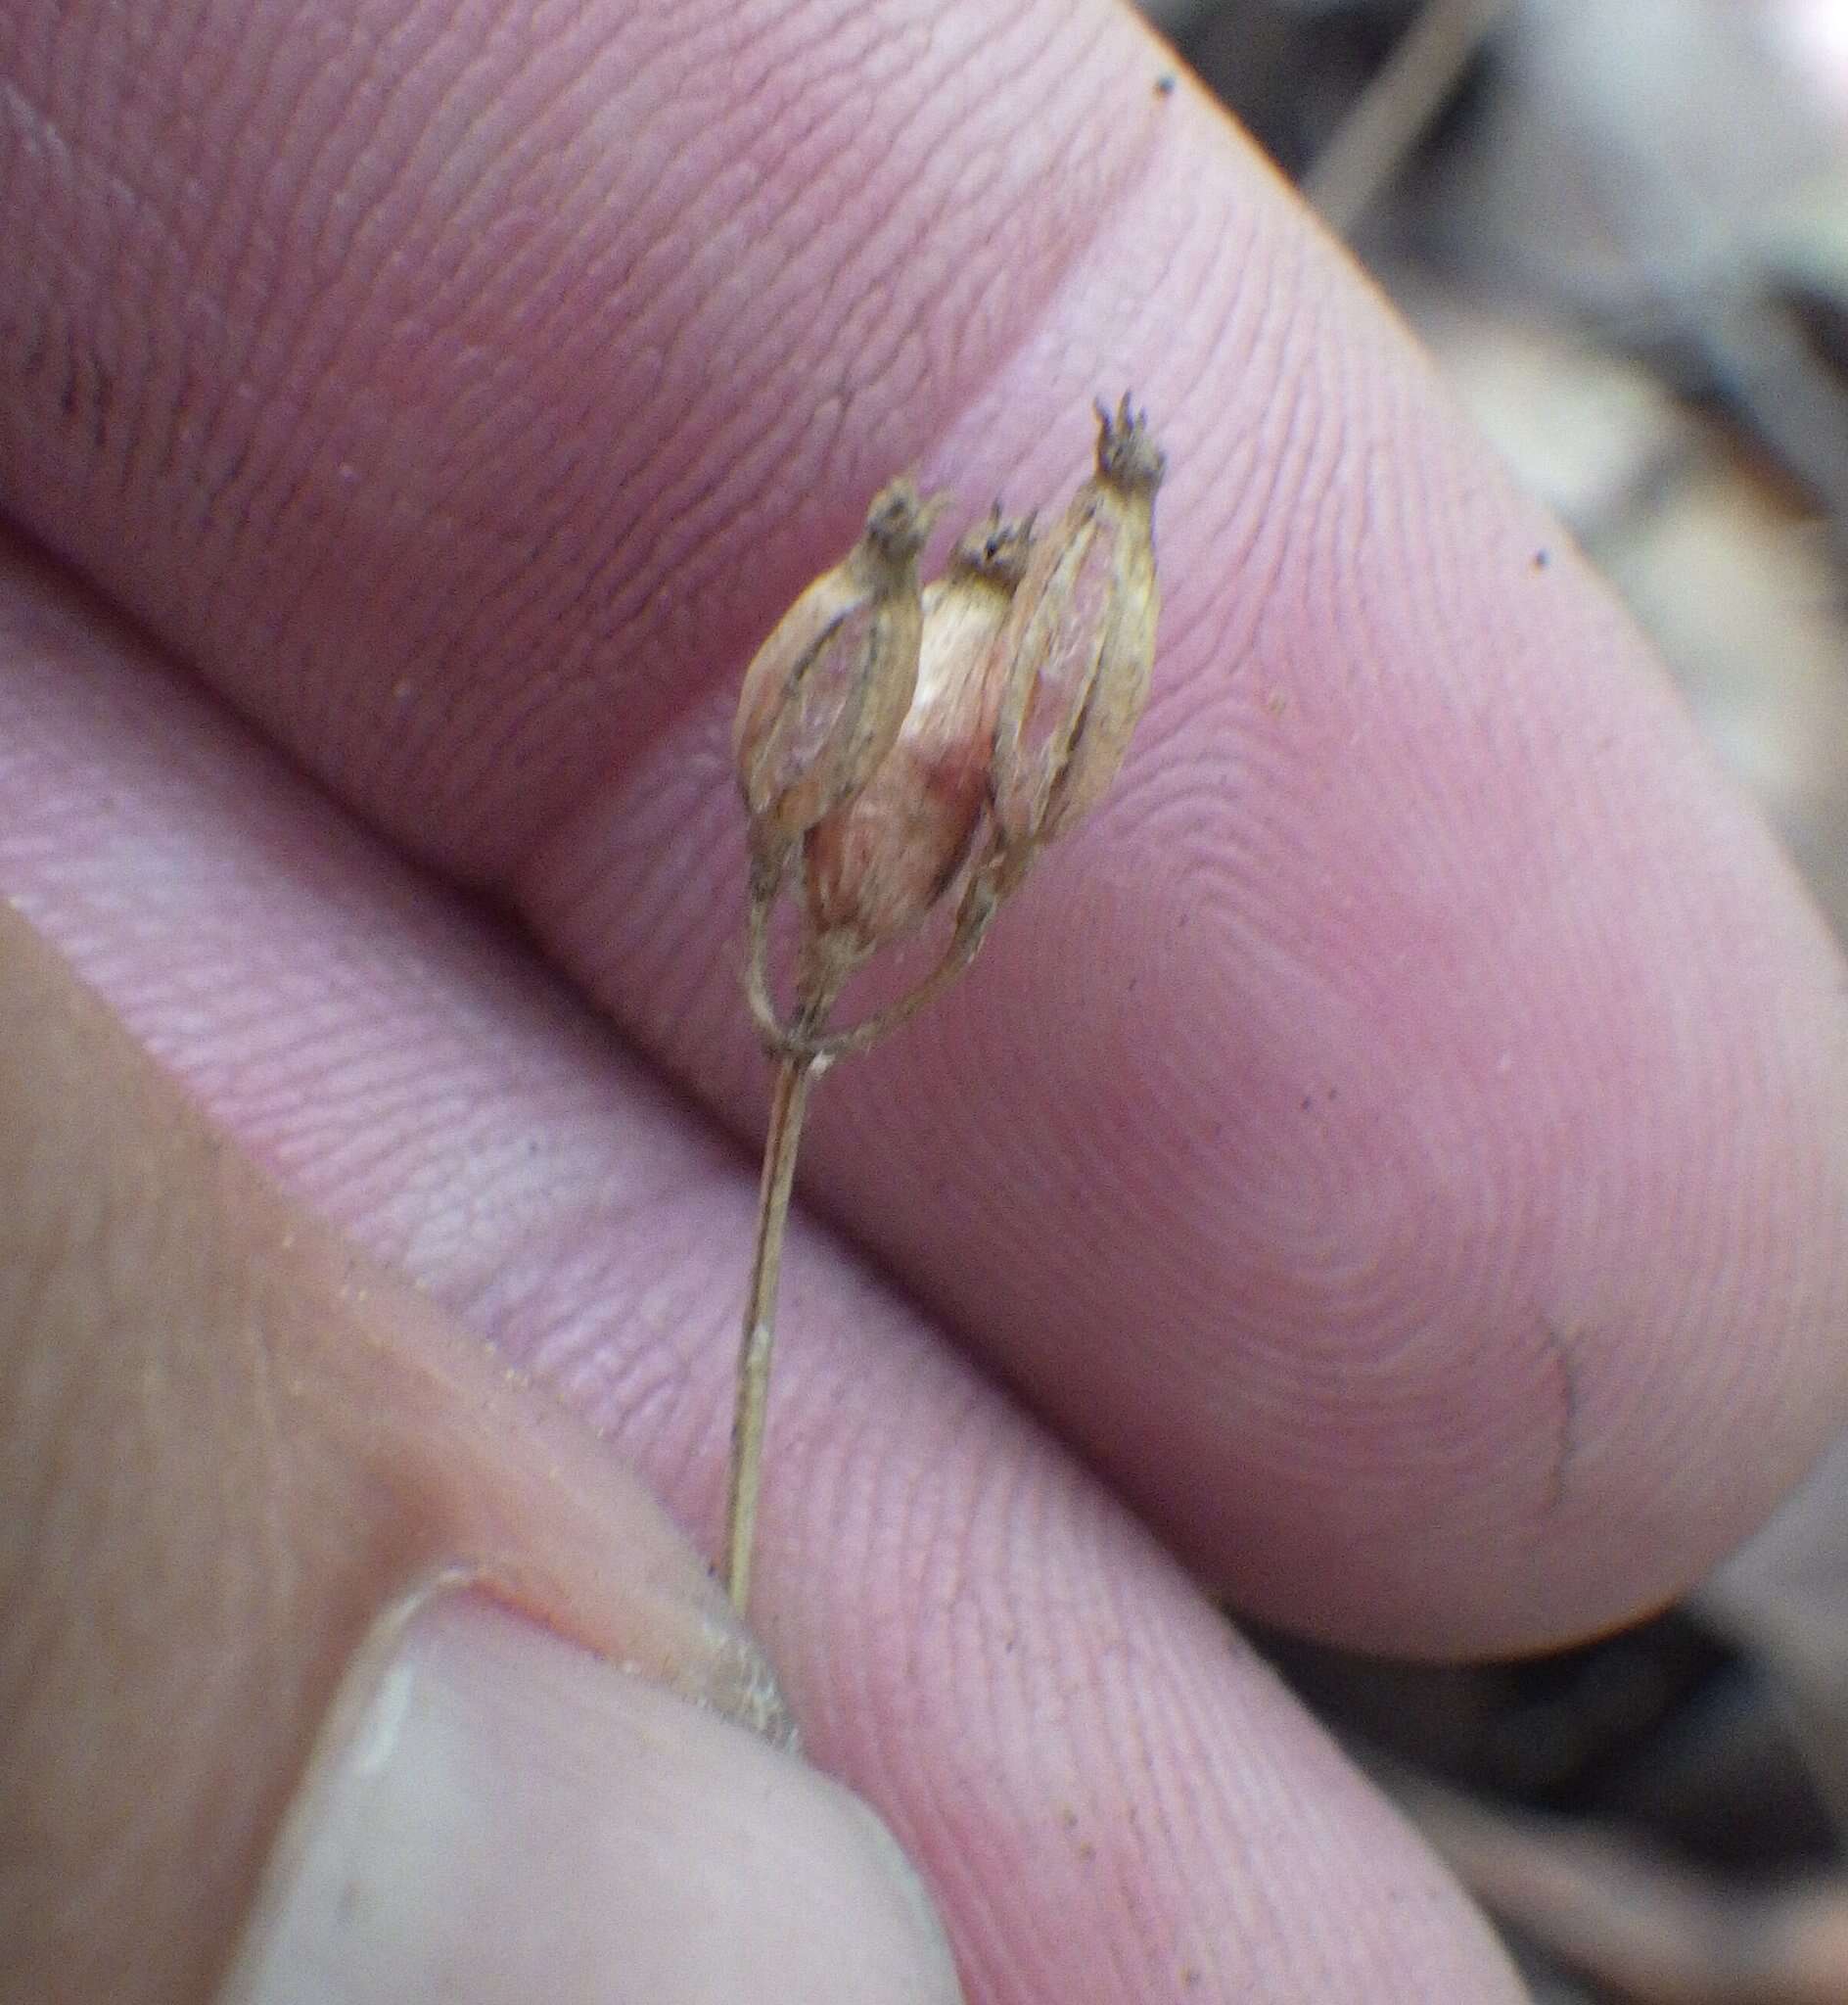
top-left (4, 0), bottom-right (1848, 1648)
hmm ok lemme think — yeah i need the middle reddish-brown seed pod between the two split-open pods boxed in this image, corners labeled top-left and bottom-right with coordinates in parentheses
top-left (806, 505), bottom-right (1033, 966)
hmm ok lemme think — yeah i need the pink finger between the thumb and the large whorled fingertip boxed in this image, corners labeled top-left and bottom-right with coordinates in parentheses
top-left (0, 549), bottom-right (1515, 2005)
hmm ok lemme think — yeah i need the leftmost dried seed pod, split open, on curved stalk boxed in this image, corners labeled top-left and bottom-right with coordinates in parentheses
top-left (731, 479), bottom-right (947, 886)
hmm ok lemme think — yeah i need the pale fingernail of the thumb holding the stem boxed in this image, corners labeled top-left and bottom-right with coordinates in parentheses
top-left (222, 1594), bottom-right (960, 2005)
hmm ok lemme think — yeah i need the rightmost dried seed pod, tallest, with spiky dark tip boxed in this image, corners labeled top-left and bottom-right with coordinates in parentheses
top-left (993, 397), bottom-right (1167, 886)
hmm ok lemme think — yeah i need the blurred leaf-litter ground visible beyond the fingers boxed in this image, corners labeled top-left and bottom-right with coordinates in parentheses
top-left (1144, 0), bottom-right (1848, 2005)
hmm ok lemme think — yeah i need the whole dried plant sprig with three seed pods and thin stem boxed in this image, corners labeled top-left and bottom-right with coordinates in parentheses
top-left (723, 397), bottom-right (1167, 1610)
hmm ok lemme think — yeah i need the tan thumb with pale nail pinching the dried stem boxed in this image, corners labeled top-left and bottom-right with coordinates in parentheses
top-left (0, 907), bottom-right (958, 2005)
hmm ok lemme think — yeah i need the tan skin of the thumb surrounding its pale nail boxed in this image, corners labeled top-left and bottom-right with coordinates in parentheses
top-left (0, 912), bottom-right (784, 2005)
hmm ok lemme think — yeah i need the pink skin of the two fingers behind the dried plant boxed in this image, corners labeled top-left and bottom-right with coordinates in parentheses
top-left (0, 0), bottom-right (1848, 2001)
